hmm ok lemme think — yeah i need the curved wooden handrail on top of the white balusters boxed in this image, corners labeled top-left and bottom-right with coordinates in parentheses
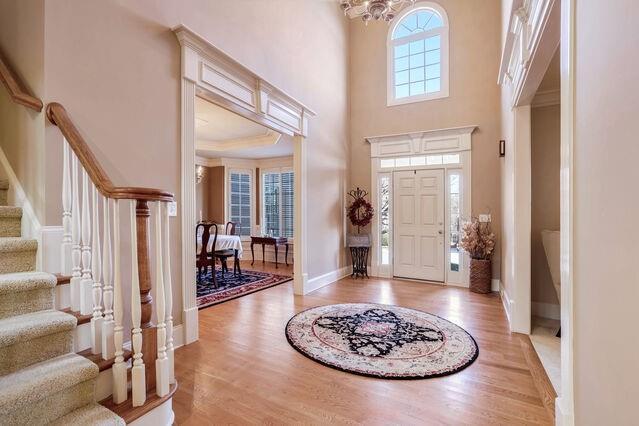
top-left (47, 102), bottom-right (174, 201)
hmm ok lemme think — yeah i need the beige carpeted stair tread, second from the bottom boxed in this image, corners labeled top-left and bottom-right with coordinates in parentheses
top-left (0, 353), bottom-right (99, 420)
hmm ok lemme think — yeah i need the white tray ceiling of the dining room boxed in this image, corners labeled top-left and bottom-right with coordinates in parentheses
top-left (195, 98), bottom-right (293, 159)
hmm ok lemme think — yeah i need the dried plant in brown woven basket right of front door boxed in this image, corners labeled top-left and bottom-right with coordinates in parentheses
top-left (459, 217), bottom-right (495, 293)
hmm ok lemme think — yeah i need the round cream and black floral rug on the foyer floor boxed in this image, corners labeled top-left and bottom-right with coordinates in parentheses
top-left (286, 303), bottom-right (479, 379)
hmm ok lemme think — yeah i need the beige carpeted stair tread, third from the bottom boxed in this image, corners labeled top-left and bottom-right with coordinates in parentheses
top-left (0, 310), bottom-right (77, 350)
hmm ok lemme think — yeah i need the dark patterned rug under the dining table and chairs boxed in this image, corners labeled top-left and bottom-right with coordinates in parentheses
top-left (197, 268), bottom-right (293, 309)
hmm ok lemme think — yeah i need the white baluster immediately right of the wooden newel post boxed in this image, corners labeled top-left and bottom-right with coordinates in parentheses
top-left (155, 201), bottom-right (169, 397)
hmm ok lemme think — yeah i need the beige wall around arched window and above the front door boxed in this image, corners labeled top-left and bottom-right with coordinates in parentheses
top-left (350, 0), bottom-right (501, 277)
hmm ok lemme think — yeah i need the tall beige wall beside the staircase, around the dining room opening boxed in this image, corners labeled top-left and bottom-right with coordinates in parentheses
top-left (0, 0), bottom-right (349, 323)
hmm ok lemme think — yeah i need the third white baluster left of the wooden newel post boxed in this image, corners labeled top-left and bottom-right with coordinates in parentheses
top-left (101, 198), bottom-right (115, 359)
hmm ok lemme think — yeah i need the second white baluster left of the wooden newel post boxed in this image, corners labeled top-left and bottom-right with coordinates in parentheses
top-left (112, 200), bottom-right (127, 404)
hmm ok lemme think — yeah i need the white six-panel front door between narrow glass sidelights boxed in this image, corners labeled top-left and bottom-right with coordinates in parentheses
top-left (393, 169), bottom-right (445, 282)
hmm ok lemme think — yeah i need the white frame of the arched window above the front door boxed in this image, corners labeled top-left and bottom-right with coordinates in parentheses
top-left (386, 1), bottom-right (450, 106)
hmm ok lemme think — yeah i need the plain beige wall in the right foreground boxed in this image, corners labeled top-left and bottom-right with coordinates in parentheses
top-left (573, 0), bottom-right (639, 425)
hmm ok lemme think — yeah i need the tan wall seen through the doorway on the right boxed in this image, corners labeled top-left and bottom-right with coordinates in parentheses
top-left (530, 105), bottom-right (560, 304)
